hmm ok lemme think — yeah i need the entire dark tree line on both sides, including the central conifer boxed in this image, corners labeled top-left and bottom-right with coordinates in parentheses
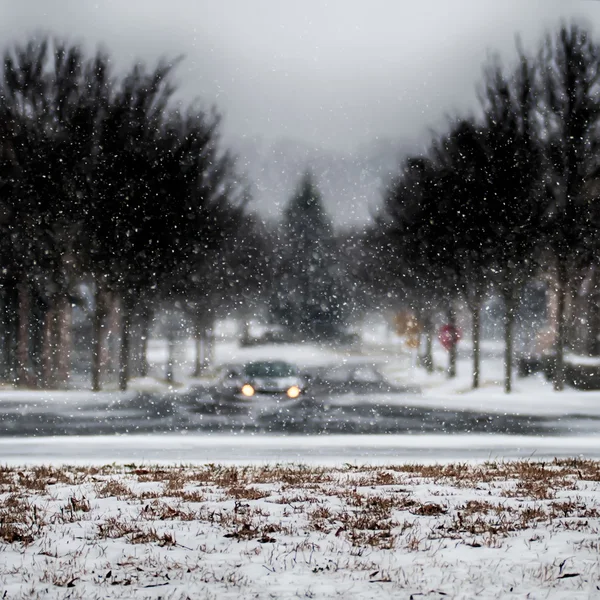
top-left (0, 24), bottom-right (600, 391)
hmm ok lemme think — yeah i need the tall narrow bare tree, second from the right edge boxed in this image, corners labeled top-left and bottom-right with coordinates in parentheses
top-left (480, 45), bottom-right (544, 393)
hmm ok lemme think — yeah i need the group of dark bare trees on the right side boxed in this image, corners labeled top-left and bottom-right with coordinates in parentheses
top-left (372, 23), bottom-right (600, 392)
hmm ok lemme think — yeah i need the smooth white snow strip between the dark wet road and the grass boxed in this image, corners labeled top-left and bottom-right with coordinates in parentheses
top-left (0, 434), bottom-right (600, 465)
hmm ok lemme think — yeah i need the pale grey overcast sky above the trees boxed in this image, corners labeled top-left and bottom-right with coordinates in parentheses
top-left (0, 0), bottom-right (600, 150)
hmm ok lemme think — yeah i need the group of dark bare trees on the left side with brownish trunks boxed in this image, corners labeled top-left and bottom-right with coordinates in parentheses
top-left (0, 38), bottom-right (262, 390)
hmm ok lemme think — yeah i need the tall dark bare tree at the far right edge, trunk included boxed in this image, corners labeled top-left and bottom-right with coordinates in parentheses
top-left (540, 23), bottom-right (600, 390)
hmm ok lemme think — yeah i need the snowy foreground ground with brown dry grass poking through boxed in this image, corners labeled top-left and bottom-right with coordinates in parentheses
top-left (0, 459), bottom-right (600, 599)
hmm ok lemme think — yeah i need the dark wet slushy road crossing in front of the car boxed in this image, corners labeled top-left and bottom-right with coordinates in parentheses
top-left (0, 388), bottom-right (600, 437)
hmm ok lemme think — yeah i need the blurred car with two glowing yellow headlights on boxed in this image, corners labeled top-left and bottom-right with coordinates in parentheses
top-left (217, 360), bottom-right (307, 400)
